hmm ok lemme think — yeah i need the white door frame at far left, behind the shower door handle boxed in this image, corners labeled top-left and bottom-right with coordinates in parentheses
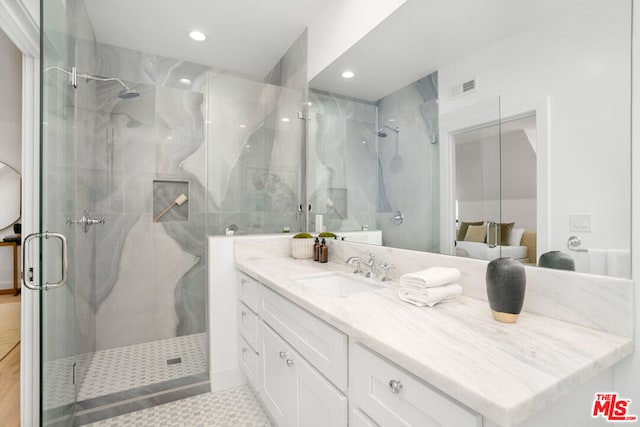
top-left (0, 0), bottom-right (40, 426)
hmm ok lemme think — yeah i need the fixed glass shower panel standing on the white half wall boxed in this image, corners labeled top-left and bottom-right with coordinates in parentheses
top-left (207, 72), bottom-right (304, 234)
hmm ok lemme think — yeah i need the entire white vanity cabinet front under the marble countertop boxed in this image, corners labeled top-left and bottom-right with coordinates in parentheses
top-left (238, 274), bottom-right (482, 427)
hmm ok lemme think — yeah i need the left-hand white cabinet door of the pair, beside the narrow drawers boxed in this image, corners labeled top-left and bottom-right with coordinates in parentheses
top-left (258, 322), bottom-right (297, 427)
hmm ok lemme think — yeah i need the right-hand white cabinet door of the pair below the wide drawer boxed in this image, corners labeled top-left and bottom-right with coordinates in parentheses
top-left (293, 353), bottom-right (348, 427)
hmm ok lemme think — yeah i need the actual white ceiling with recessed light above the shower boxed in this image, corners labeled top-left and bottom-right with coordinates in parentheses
top-left (85, 0), bottom-right (329, 78)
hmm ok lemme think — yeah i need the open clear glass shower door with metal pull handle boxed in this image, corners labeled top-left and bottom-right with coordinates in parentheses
top-left (36, 1), bottom-right (88, 426)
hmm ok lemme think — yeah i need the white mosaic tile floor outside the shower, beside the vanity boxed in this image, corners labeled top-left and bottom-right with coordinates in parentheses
top-left (81, 385), bottom-right (272, 427)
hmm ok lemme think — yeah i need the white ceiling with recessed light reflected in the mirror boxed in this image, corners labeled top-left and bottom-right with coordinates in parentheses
top-left (311, 0), bottom-right (580, 102)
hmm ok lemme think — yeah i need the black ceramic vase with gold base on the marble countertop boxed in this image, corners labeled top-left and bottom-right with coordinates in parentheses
top-left (486, 258), bottom-right (527, 323)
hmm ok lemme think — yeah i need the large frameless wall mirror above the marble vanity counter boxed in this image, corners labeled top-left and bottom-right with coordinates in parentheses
top-left (308, 0), bottom-right (632, 278)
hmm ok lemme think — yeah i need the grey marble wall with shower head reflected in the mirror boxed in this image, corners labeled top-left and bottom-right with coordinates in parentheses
top-left (377, 73), bottom-right (440, 252)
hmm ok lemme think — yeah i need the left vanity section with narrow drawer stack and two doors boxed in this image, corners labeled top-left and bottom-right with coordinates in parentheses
top-left (238, 274), bottom-right (348, 427)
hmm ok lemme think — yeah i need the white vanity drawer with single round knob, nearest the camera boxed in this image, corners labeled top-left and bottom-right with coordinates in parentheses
top-left (349, 344), bottom-right (482, 427)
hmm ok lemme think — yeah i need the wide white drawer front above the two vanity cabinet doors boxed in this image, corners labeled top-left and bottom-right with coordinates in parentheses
top-left (258, 286), bottom-right (347, 391)
